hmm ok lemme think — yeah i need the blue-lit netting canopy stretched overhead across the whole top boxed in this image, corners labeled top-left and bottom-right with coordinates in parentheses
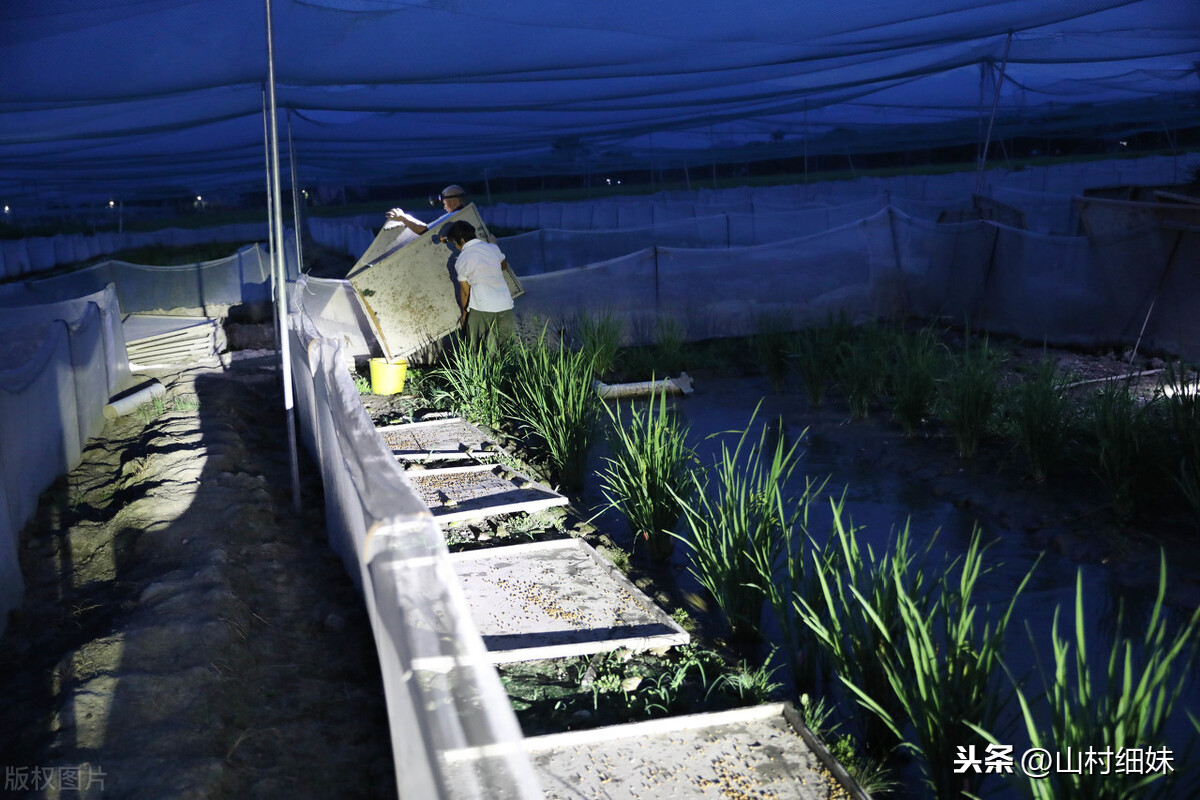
top-left (0, 0), bottom-right (1200, 204)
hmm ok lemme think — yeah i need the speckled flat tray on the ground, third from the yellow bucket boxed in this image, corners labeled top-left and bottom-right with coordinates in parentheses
top-left (450, 539), bottom-right (691, 663)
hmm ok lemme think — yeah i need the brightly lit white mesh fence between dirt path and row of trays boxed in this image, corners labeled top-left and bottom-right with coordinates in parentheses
top-left (289, 279), bottom-right (540, 800)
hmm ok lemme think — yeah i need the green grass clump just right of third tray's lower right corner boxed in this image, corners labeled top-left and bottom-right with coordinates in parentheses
top-left (680, 408), bottom-right (800, 639)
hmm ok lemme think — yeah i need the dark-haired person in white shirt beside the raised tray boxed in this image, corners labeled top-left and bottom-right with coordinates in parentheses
top-left (442, 219), bottom-right (516, 348)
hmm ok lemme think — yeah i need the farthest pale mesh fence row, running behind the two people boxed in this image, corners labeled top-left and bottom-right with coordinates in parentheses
top-left (310, 154), bottom-right (1200, 276)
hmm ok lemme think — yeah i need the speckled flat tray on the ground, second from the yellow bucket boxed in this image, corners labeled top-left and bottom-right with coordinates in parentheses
top-left (406, 464), bottom-right (569, 524)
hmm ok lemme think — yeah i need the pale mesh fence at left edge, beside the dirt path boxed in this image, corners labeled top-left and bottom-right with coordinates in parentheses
top-left (0, 285), bottom-right (131, 634)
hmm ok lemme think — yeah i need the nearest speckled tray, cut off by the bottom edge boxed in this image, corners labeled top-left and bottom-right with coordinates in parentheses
top-left (523, 703), bottom-right (868, 800)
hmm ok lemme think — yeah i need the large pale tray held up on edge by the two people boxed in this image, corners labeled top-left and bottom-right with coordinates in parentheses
top-left (346, 204), bottom-right (524, 361)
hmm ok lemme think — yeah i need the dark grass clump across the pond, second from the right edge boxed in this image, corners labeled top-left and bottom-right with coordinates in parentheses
top-left (1084, 381), bottom-right (1151, 517)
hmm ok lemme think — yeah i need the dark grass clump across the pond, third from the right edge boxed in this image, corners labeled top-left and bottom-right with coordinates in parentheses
top-left (1014, 360), bottom-right (1070, 483)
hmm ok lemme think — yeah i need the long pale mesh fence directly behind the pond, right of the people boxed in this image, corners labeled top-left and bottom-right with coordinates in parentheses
top-left (517, 203), bottom-right (1200, 359)
